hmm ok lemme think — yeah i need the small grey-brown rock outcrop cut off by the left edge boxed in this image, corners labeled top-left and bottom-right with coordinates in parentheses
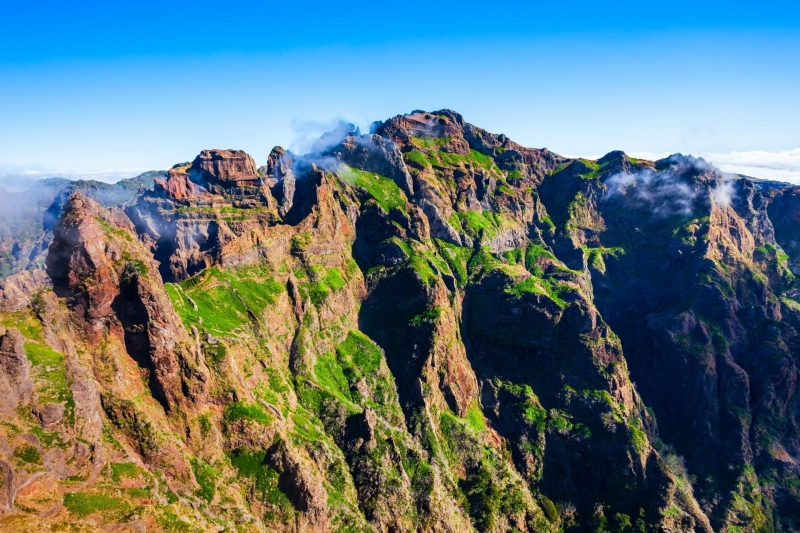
top-left (0, 328), bottom-right (33, 413)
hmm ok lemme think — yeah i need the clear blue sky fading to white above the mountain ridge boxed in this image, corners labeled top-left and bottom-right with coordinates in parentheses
top-left (0, 0), bottom-right (800, 187)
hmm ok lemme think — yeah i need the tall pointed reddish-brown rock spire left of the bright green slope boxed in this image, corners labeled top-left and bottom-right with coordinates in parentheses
top-left (47, 193), bottom-right (208, 410)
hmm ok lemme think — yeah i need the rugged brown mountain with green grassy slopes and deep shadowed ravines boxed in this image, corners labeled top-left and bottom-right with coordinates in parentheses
top-left (0, 110), bottom-right (800, 533)
